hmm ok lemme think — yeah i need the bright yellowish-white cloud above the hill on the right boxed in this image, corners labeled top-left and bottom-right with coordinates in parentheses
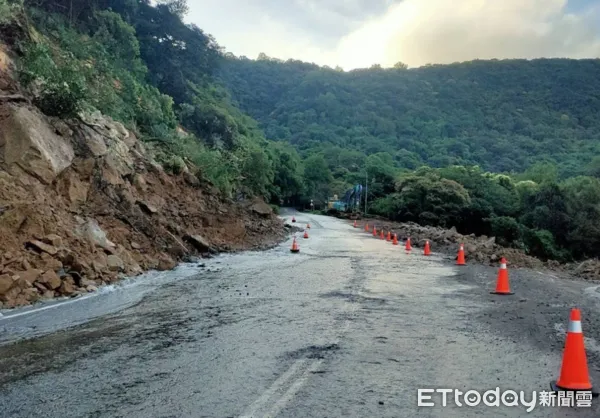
top-left (336, 0), bottom-right (600, 68)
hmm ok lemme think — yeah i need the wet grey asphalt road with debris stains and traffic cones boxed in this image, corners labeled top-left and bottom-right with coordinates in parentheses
top-left (0, 212), bottom-right (600, 418)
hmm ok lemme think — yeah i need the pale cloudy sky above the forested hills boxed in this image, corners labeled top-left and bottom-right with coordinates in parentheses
top-left (186, 0), bottom-right (600, 70)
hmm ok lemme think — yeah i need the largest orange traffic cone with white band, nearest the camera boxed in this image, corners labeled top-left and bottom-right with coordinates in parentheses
top-left (550, 308), bottom-right (598, 396)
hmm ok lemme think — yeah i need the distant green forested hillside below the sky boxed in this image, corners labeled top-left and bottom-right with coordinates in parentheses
top-left (220, 55), bottom-right (600, 177)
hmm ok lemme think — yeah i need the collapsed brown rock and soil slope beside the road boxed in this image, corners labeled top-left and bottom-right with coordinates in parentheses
top-left (0, 45), bottom-right (285, 308)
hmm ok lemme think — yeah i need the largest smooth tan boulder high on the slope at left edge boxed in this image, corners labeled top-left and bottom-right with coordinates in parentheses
top-left (0, 105), bottom-right (75, 184)
